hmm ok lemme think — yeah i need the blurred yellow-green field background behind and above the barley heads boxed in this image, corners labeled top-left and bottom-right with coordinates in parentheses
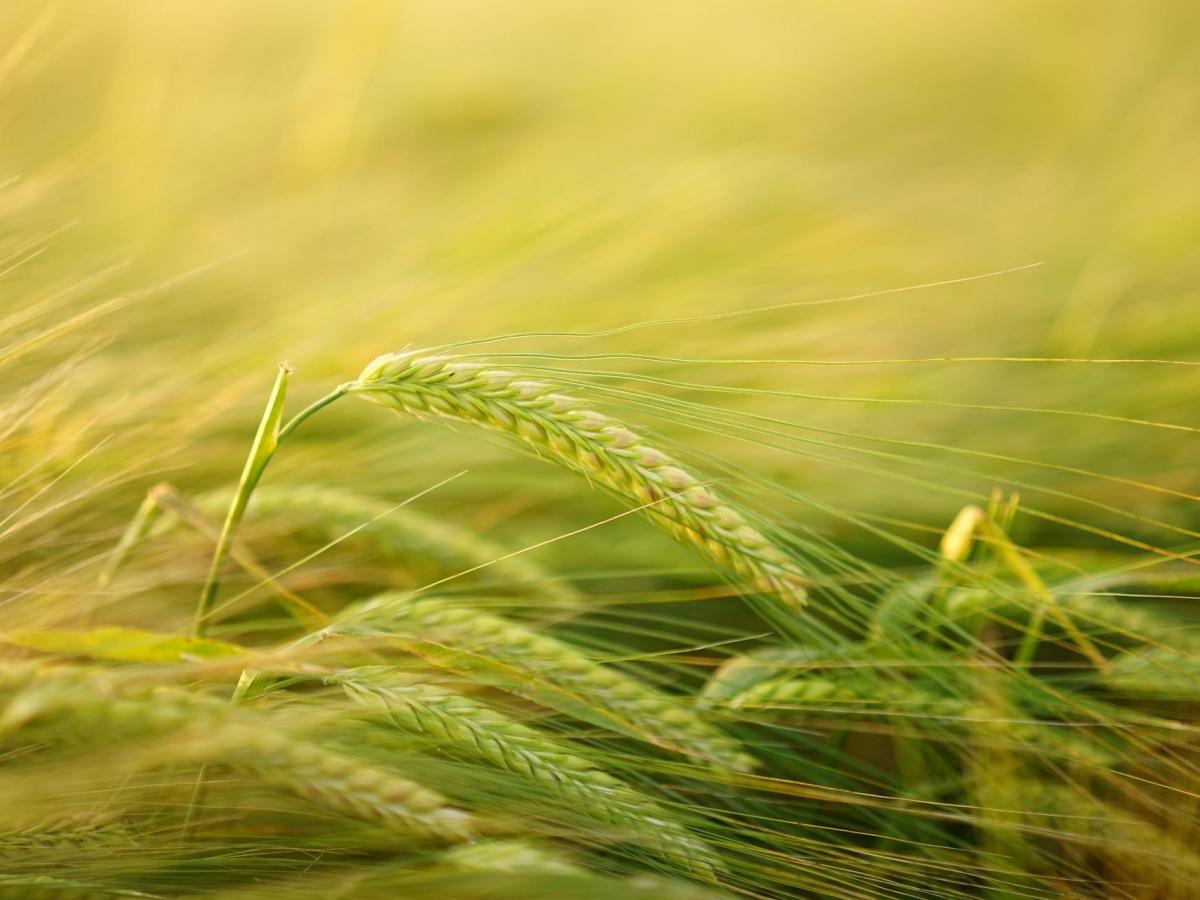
top-left (0, 0), bottom-right (1200, 607)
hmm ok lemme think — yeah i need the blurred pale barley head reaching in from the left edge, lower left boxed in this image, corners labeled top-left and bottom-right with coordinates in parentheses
top-left (0, 665), bottom-right (476, 842)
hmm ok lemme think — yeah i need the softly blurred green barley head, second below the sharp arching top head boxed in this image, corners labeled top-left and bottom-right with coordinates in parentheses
top-left (331, 594), bottom-right (756, 772)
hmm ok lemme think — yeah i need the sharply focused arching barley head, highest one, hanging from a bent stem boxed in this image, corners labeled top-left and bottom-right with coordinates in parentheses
top-left (348, 353), bottom-right (805, 611)
